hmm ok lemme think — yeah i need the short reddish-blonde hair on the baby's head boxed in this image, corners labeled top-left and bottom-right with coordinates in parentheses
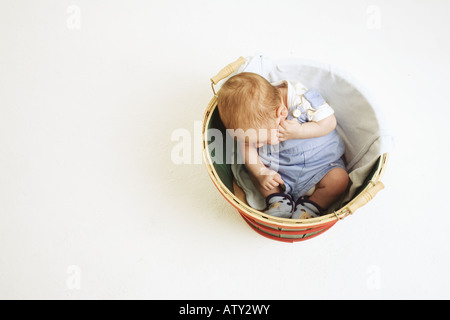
top-left (218, 72), bottom-right (281, 130)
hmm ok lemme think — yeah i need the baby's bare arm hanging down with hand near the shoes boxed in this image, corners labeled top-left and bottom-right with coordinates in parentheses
top-left (241, 143), bottom-right (284, 197)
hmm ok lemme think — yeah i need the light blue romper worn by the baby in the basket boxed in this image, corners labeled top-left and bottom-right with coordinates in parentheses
top-left (258, 87), bottom-right (345, 201)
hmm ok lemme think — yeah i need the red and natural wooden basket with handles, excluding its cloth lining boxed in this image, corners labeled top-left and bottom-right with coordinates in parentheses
top-left (202, 57), bottom-right (388, 242)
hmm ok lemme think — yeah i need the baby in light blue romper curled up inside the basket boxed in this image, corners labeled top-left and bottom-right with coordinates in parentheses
top-left (218, 72), bottom-right (349, 219)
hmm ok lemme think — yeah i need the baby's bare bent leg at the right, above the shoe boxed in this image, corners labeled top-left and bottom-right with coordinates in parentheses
top-left (309, 168), bottom-right (349, 209)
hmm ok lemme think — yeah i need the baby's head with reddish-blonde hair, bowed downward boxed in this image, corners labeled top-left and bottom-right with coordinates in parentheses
top-left (218, 72), bottom-right (286, 145)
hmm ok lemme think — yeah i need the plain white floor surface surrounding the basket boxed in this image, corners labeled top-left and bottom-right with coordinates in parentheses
top-left (0, 0), bottom-right (450, 299)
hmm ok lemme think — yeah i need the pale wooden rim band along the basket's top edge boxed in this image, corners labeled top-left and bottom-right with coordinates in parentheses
top-left (202, 93), bottom-right (389, 228)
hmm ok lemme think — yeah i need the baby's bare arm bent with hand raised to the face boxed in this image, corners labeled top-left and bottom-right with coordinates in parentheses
top-left (279, 114), bottom-right (337, 141)
